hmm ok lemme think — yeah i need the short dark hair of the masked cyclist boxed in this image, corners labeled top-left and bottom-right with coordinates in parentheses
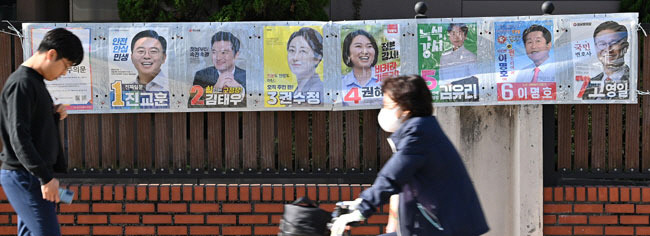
top-left (381, 75), bottom-right (433, 118)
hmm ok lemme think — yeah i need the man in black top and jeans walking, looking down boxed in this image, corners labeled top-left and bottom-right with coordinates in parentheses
top-left (0, 28), bottom-right (84, 236)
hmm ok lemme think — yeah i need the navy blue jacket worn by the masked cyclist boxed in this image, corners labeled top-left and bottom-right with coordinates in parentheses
top-left (358, 116), bottom-right (489, 236)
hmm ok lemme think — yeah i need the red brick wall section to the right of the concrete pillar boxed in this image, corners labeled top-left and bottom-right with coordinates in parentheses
top-left (544, 186), bottom-right (650, 235)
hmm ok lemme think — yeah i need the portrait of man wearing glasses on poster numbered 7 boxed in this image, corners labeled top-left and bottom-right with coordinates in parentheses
top-left (582, 21), bottom-right (630, 99)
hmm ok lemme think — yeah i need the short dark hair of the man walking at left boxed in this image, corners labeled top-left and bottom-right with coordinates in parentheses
top-left (37, 28), bottom-right (84, 66)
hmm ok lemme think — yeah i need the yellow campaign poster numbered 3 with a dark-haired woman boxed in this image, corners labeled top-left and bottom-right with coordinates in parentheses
top-left (264, 25), bottom-right (325, 107)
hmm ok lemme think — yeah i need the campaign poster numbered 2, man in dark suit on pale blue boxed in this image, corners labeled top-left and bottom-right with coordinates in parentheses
top-left (185, 25), bottom-right (248, 108)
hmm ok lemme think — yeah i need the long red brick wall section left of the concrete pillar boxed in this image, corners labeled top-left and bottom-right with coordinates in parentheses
top-left (0, 184), bottom-right (388, 235)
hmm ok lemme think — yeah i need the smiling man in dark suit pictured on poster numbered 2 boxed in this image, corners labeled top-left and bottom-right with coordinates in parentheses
top-left (193, 31), bottom-right (246, 91)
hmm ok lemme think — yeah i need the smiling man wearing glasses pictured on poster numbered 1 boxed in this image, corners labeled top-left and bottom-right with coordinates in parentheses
top-left (131, 30), bottom-right (169, 91)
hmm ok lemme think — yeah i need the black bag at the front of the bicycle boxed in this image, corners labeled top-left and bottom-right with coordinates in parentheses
top-left (278, 197), bottom-right (332, 236)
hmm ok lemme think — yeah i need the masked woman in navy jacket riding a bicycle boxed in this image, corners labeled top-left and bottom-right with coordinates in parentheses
top-left (331, 75), bottom-right (489, 236)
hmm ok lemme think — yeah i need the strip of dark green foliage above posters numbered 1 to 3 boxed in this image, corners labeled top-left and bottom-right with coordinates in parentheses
top-left (118, 0), bottom-right (329, 22)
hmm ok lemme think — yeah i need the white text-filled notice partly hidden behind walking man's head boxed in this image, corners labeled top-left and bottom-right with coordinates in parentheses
top-left (30, 28), bottom-right (93, 110)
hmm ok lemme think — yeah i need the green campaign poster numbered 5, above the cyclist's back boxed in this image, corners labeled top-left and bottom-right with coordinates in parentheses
top-left (418, 23), bottom-right (479, 102)
